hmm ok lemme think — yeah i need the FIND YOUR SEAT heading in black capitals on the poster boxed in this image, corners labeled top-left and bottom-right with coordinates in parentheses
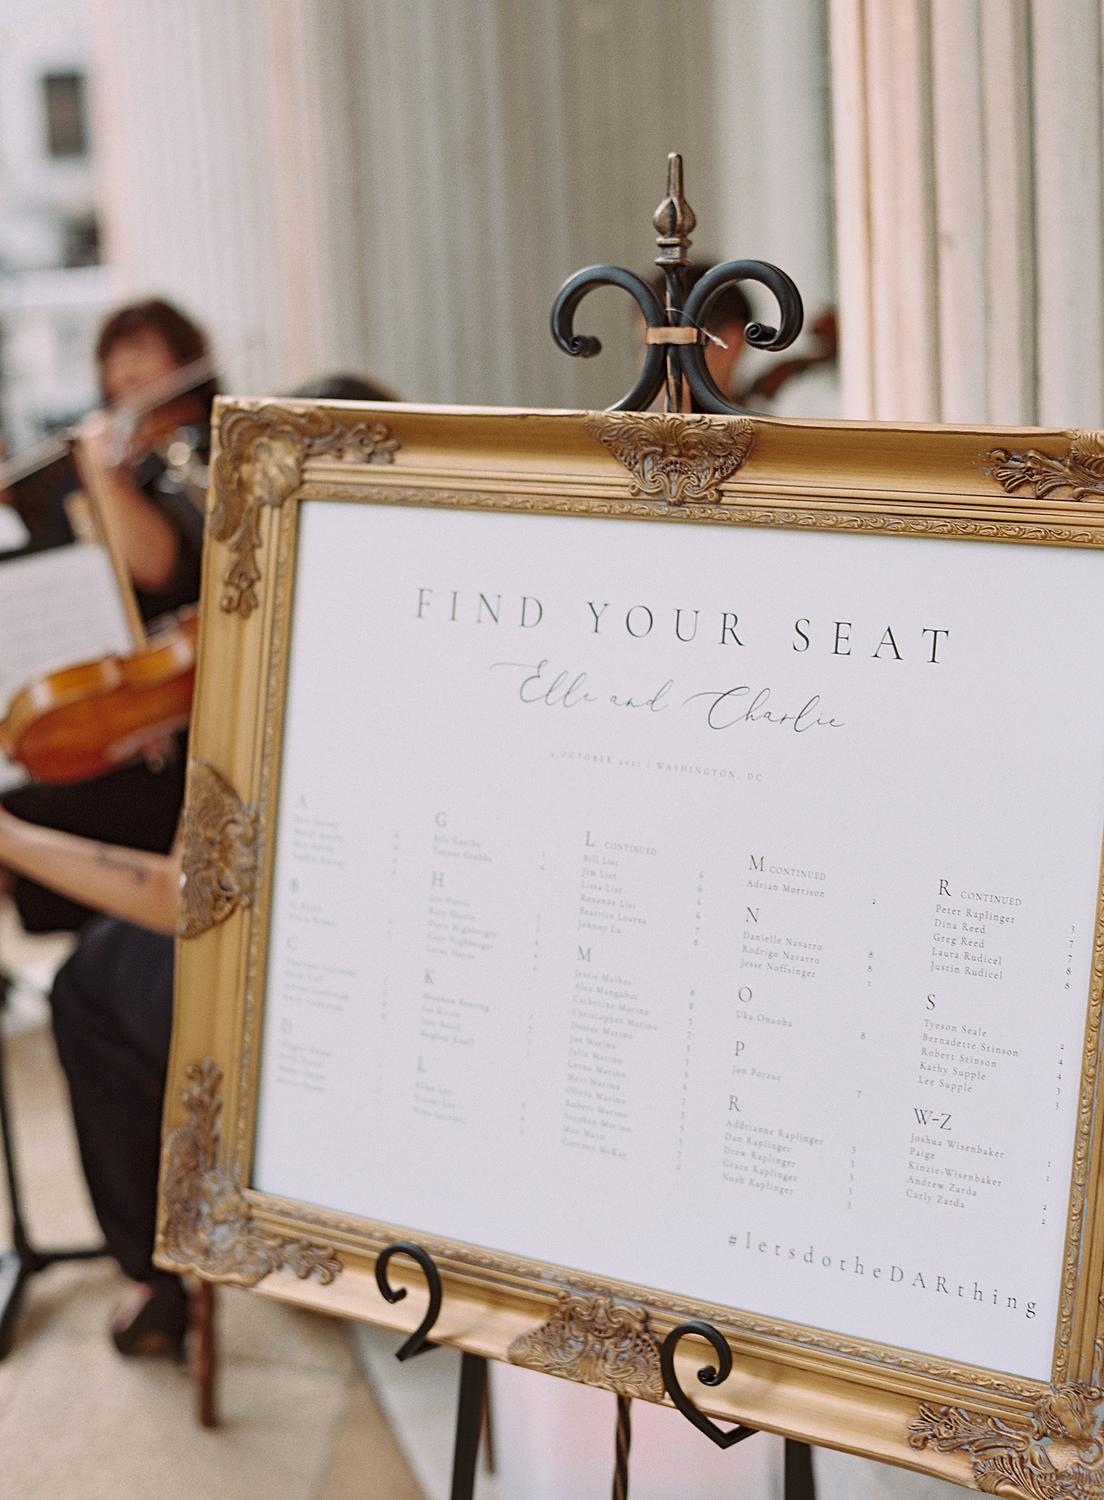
top-left (416, 588), bottom-right (951, 666)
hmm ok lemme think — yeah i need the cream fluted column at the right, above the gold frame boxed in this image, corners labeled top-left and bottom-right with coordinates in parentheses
top-left (831, 0), bottom-right (1104, 425)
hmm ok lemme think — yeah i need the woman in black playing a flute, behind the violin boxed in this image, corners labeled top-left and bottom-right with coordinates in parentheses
top-left (0, 299), bottom-right (218, 932)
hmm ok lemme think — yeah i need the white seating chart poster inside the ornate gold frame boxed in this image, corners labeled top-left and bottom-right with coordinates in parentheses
top-left (254, 501), bottom-right (1104, 1380)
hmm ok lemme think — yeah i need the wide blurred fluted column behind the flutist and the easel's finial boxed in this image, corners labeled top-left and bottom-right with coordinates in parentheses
top-left (93, 0), bottom-right (729, 405)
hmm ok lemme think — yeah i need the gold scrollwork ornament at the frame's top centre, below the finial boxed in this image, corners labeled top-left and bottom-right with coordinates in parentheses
top-left (587, 411), bottom-right (755, 506)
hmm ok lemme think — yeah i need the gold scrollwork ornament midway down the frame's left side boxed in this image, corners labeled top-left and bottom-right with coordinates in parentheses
top-left (177, 759), bottom-right (258, 938)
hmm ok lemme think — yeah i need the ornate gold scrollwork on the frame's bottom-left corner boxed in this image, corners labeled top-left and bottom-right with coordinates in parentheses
top-left (156, 1058), bottom-right (342, 1287)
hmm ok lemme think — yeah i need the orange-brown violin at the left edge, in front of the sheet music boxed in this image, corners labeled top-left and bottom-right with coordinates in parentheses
top-left (0, 609), bottom-right (200, 783)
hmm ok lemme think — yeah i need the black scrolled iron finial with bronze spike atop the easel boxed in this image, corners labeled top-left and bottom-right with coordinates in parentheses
top-left (552, 152), bottom-right (804, 417)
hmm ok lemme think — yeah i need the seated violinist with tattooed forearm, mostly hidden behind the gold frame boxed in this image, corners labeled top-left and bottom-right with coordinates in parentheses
top-left (0, 375), bottom-right (393, 1355)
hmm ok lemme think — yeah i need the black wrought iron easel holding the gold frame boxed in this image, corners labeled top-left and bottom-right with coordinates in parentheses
top-left (375, 153), bottom-right (816, 1500)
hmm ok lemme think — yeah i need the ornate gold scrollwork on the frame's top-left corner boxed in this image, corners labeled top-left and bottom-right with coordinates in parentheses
top-left (207, 402), bottom-right (402, 620)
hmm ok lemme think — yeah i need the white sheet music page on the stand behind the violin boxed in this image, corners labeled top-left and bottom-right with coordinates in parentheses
top-left (0, 546), bottom-right (131, 788)
